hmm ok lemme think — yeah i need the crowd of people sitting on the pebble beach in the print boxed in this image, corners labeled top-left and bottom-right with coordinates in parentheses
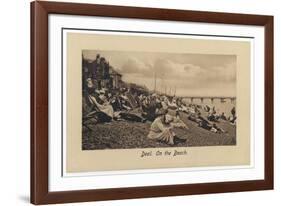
top-left (83, 54), bottom-right (236, 145)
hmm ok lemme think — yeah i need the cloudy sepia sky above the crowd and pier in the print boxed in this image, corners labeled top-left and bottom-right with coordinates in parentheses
top-left (83, 50), bottom-right (236, 96)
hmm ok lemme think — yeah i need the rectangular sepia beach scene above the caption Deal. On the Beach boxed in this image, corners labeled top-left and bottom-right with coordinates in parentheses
top-left (81, 50), bottom-right (237, 150)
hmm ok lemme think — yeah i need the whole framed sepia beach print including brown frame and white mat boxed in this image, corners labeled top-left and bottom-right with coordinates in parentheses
top-left (31, 1), bottom-right (273, 204)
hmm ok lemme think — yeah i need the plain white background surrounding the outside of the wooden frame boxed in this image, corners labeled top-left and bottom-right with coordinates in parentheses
top-left (0, 0), bottom-right (281, 206)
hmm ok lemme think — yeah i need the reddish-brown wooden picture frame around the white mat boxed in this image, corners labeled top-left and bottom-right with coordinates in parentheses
top-left (31, 1), bottom-right (273, 204)
